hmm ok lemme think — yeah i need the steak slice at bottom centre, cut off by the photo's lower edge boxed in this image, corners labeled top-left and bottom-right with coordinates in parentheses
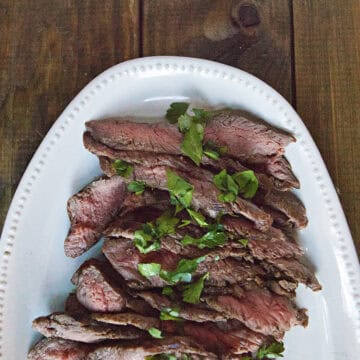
top-left (87, 336), bottom-right (217, 360)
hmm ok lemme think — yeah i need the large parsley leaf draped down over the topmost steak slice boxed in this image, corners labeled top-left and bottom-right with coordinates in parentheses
top-left (181, 123), bottom-right (204, 166)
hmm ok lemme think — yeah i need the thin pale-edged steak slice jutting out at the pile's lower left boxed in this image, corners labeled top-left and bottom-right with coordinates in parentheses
top-left (33, 313), bottom-right (143, 343)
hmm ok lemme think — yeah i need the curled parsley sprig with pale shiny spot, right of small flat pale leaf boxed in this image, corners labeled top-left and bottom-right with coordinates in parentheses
top-left (160, 256), bottom-right (206, 285)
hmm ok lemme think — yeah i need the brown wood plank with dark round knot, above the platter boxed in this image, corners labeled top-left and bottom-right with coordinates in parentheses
top-left (142, 0), bottom-right (292, 101)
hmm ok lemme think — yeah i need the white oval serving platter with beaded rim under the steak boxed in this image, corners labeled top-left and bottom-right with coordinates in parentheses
top-left (0, 56), bottom-right (360, 360)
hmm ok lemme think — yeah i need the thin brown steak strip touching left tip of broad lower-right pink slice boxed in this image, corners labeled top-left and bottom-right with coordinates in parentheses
top-left (136, 291), bottom-right (227, 322)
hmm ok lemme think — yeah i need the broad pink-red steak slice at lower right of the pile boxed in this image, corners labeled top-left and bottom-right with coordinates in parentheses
top-left (206, 288), bottom-right (308, 339)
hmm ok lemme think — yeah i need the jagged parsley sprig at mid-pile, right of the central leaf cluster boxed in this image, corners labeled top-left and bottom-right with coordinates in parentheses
top-left (181, 224), bottom-right (227, 249)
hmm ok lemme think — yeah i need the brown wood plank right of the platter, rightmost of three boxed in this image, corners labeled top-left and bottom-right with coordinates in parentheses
top-left (294, 0), bottom-right (360, 254)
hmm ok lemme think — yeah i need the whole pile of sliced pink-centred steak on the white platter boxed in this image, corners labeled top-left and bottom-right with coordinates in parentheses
top-left (28, 110), bottom-right (321, 360)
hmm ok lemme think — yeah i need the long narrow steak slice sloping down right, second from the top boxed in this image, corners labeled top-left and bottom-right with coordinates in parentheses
top-left (100, 157), bottom-right (273, 231)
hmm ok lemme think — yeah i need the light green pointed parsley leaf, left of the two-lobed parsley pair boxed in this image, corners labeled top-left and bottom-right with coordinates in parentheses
top-left (166, 169), bottom-right (194, 213)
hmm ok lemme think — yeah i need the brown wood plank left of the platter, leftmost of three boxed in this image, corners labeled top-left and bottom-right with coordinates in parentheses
top-left (0, 0), bottom-right (140, 231)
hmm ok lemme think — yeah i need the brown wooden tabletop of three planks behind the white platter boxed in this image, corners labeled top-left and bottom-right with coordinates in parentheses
top-left (0, 0), bottom-right (360, 252)
